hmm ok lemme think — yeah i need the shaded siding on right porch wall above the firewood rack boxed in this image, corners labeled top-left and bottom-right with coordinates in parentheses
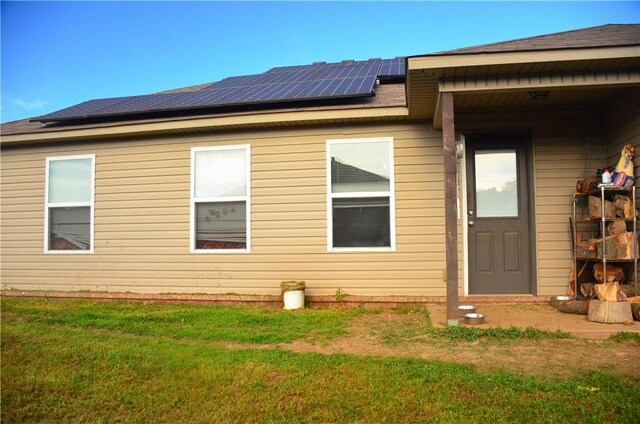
top-left (606, 88), bottom-right (640, 199)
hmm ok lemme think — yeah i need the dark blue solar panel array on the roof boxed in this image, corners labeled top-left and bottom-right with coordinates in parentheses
top-left (32, 58), bottom-right (404, 122)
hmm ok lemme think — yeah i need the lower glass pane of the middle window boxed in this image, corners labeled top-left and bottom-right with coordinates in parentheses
top-left (196, 202), bottom-right (247, 249)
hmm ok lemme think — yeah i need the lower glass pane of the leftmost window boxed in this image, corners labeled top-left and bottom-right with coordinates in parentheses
top-left (49, 207), bottom-right (91, 250)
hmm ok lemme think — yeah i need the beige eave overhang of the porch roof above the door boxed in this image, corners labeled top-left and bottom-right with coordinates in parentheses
top-left (407, 45), bottom-right (640, 129)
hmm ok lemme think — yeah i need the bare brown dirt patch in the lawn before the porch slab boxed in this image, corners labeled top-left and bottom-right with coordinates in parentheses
top-left (279, 312), bottom-right (640, 381)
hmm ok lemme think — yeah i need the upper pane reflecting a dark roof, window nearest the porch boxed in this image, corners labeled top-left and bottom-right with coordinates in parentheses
top-left (331, 141), bottom-right (390, 193)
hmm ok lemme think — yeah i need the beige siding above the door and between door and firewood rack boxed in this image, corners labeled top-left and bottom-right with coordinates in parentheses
top-left (456, 110), bottom-right (605, 296)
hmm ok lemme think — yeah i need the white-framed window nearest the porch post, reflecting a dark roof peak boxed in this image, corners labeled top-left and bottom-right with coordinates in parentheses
top-left (327, 137), bottom-right (396, 252)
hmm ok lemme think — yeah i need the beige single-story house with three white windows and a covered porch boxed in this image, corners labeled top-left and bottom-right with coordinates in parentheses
top-left (1, 25), bottom-right (640, 318)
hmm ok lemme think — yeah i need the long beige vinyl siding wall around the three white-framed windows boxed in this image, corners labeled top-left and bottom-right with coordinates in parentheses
top-left (1, 123), bottom-right (445, 296)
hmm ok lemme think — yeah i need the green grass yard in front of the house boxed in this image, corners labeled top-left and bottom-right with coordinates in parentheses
top-left (1, 299), bottom-right (640, 423)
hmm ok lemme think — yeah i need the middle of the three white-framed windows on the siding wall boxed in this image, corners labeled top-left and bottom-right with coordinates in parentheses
top-left (190, 145), bottom-right (251, 253)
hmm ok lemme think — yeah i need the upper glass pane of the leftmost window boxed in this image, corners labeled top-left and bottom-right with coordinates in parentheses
top-left (49, 158), bottom-right (93, 203)
